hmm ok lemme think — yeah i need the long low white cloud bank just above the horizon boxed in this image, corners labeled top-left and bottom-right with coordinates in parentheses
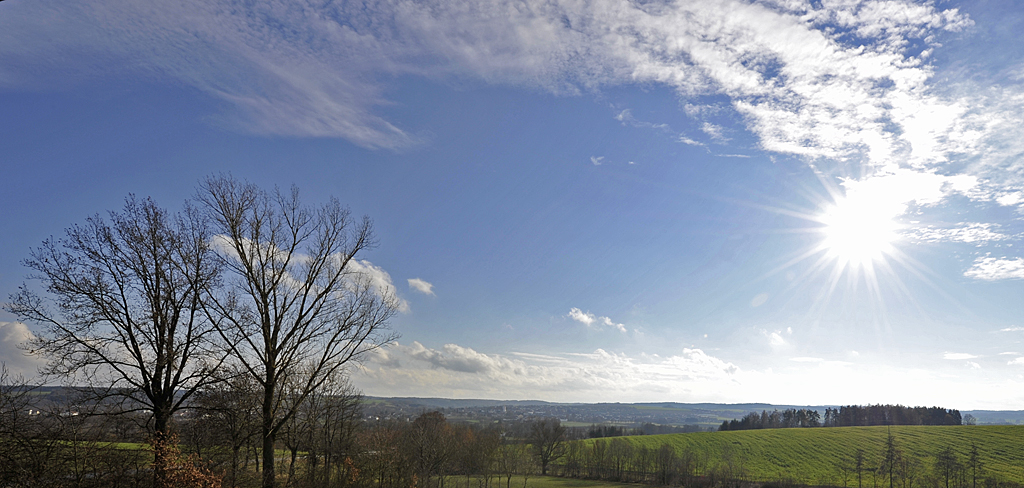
top-left (353, 343), bottom-right (1024, 409)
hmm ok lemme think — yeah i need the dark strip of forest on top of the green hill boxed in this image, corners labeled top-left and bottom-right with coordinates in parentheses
top-left (718, 405), bottom-right (964, 431)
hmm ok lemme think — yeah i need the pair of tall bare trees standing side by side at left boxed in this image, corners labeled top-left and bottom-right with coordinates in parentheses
top-left (5, 176), bottom-right (397, 488)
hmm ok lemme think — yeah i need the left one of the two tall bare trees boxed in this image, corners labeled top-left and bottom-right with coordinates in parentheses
top-left (5, 196), bottom-right (218, 486)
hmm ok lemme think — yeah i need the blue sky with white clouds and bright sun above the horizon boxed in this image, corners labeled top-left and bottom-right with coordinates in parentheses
top-left (0, 0), bottom-right (1024, 409)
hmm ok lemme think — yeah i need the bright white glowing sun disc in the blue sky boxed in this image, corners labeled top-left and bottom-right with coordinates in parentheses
top-left (817, 195), bottom-right (898, 267)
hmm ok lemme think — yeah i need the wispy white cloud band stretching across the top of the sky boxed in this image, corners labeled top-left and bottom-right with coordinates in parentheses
top-left (0, 0), bottom-right (1024, 197)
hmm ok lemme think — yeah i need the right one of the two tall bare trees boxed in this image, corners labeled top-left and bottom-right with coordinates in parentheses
top-left (198, 177), bottom-right (398, 488)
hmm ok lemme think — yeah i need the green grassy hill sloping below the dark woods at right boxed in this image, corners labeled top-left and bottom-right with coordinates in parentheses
top-left (587, 426), bottom-right (1024, 486)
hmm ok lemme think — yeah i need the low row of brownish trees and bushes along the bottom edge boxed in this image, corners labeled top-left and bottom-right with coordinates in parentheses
top-left (0, 375), bottom-right (1006, 488)
